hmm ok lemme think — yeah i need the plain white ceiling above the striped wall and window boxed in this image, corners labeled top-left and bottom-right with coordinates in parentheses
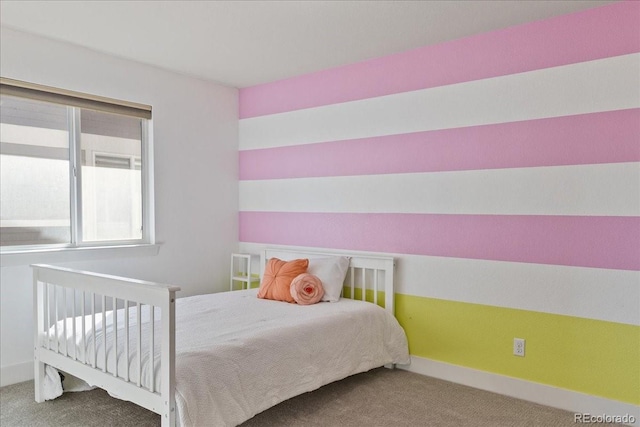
top-left (0, 0), bottom-right (611, 87)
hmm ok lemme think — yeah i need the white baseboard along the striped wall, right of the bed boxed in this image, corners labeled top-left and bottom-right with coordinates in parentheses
top-left (396, 356), bottom-right (640, 427)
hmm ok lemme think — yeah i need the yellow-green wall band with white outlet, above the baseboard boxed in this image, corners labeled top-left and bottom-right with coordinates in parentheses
top-left (396, 294), bottom-right (640, 405)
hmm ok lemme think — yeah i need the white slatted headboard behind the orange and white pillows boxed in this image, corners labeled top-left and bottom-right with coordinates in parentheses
top-left (260, 248), bottom-right (395, 314)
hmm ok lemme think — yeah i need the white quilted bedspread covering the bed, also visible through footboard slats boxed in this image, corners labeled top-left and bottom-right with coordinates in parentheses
top-left (42, 289), bottom-right (409, 426)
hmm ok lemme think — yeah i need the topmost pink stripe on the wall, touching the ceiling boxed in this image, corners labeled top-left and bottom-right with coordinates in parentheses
top-left (240, 1), bottom-right (640, 118)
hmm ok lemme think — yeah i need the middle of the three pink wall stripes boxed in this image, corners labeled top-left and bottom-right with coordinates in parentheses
top-left (240, 109), bottom-right (640, 180)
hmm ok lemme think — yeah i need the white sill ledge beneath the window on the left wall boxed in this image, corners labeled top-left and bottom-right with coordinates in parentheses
top-left (0, 244), bottom-right (160, 267)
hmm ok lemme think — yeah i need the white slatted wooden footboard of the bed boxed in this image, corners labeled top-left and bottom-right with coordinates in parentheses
top-left (32, 265), bottom-right (180, 427)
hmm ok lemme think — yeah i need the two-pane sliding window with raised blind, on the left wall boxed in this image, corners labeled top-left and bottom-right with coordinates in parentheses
top-left (0, 79), bottom-right (153, 253)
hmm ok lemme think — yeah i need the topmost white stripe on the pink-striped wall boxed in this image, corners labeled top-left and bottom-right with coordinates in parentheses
top-left (239, 54), bottom-right (640, 150)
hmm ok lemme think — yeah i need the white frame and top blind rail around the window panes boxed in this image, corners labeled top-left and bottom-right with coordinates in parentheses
top-left (0, 77), bottom-right (159, 260)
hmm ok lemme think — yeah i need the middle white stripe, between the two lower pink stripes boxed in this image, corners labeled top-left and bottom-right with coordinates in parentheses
top-left (240, 162), bottom-right (640, 216)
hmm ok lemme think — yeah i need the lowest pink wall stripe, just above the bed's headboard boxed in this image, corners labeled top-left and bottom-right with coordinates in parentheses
top-left (240, 212), bottom-right (640, 270)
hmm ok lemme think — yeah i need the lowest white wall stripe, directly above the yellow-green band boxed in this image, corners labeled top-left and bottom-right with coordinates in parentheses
top-left (240, 242), bottom-right (640, 326)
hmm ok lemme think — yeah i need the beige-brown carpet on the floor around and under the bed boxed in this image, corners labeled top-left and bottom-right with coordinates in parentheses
top-left (0, 368), bottom-right (616, 427)
